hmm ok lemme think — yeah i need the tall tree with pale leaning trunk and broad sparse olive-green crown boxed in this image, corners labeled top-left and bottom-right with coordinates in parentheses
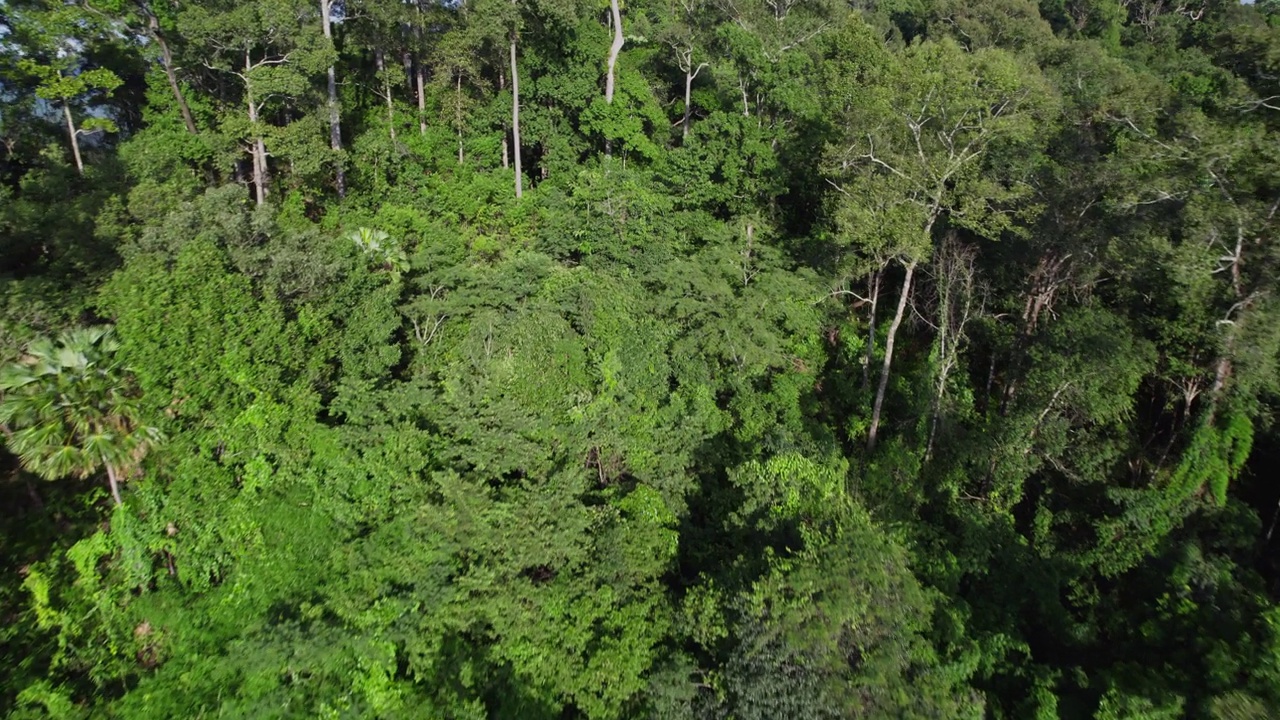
top-left (827, 30), bottom-right (1051, 450)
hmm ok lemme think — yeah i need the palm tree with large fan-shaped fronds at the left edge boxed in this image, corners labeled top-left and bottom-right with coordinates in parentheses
top-left (0, 327), bottom-right (163, 506)
